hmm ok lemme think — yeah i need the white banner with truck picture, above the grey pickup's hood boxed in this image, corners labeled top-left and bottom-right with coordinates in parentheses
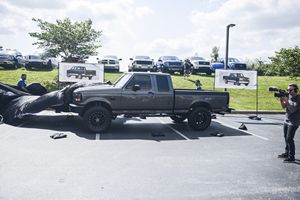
top-left (58, 63), bottom-right (104, 82)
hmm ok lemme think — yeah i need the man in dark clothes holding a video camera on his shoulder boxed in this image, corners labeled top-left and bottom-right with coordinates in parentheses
top-left (278, 84), bottom-right (300, 162)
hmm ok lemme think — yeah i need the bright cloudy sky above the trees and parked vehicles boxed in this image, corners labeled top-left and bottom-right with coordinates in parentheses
top-left (0, 0), bottom-right (300, 67)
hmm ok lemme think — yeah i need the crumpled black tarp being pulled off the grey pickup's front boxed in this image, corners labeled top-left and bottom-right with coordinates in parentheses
top-left (0, 82), bottom-right (107, 124)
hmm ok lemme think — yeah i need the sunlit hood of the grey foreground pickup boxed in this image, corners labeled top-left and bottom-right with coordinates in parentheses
top-left (74, 84), bottom-right (121, 94)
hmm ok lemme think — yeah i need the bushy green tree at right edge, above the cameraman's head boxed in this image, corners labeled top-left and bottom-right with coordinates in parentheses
top-left (269, 46), bottom-right (300, 79)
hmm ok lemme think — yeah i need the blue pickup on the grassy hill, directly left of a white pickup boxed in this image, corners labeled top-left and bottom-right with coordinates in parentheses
top-left (156, 56), bottom-right (184, 74)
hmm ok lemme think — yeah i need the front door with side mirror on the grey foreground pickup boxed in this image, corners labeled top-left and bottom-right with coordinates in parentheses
top-left (121, 74), bottom-right (154, 111)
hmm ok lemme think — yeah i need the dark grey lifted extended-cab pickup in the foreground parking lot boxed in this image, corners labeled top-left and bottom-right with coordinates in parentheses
top-left (69, 72), bottom-right (230, 132)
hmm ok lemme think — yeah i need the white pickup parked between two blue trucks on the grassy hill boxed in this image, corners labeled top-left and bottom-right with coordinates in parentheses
top-left (188, 56), bottom-right (212, 75)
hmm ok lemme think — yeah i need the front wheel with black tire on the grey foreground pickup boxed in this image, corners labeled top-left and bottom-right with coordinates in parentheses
top-left (83, 106), bottom-right (112, 132)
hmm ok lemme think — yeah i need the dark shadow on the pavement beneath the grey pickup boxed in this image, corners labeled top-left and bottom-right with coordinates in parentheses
top-left (16, 115), bottom-right (250, 142)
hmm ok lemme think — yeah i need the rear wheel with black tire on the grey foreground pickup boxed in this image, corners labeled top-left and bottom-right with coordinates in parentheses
top-left (188, 107), bottom-right (211, 130)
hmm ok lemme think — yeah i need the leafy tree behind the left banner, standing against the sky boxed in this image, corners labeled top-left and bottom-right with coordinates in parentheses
top-left (29, 18), bottom-right (102, 62)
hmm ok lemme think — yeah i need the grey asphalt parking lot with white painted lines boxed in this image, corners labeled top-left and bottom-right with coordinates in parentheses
top-left (0, 111), bottom-right (300, 200)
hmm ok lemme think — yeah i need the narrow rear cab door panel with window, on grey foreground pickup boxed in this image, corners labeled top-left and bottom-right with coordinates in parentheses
top-left (154, 75), bottom-right (174, 111)
